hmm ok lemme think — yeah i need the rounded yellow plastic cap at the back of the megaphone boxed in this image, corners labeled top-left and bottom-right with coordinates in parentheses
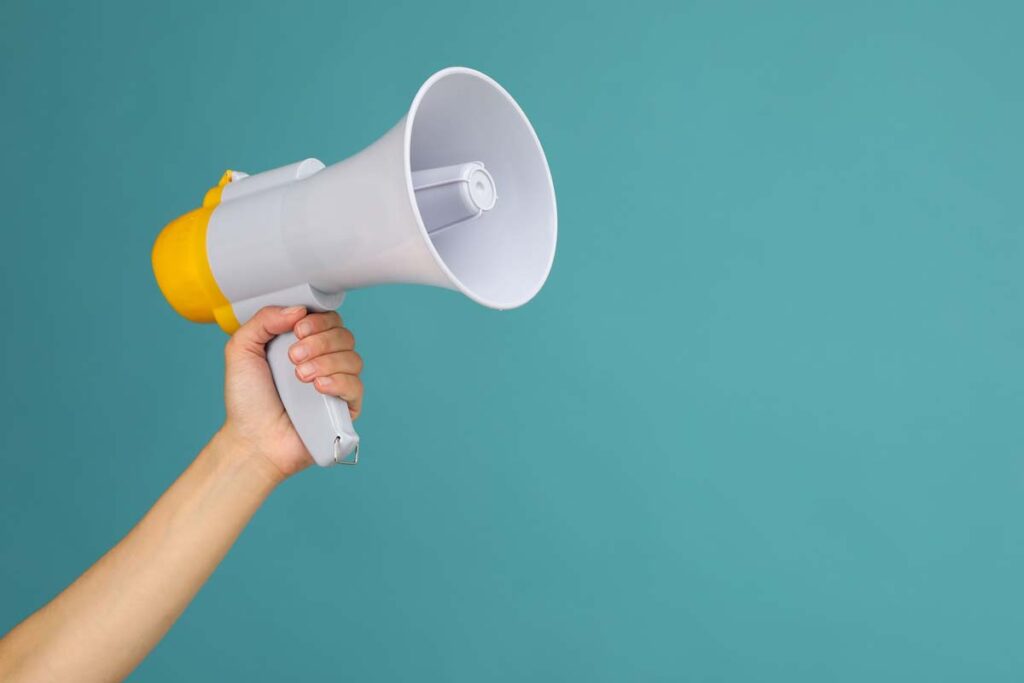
top-left (153, 171), bottom-right (240, 334)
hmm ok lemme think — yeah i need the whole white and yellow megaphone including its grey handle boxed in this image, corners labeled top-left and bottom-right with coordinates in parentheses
top-left (153, 67), bottom-right (558, 467)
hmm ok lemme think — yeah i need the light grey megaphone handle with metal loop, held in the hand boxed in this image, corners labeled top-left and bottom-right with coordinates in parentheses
top-left (266, 332), bottom-right (359, 467)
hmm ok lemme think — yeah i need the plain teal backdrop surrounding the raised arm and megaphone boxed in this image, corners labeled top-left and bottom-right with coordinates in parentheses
top-left (0, 1), bottom-right (1024, 681)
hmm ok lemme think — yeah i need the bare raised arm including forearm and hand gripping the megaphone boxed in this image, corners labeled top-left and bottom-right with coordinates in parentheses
top-left (0, 307), bottom-right (362, 683)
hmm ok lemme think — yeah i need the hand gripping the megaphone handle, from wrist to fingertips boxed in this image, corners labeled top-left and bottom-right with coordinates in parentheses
top-left (221, 306), bottom-right (362, 479)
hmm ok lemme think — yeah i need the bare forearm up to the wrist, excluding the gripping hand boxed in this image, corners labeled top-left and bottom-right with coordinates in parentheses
top-left (0, 435), bottom-right (281, 681)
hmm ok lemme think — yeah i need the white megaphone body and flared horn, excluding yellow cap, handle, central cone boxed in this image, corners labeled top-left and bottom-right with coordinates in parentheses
top-left (207, 68), bottom-right (557, 308)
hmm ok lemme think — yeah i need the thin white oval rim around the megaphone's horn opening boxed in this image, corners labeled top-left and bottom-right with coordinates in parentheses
top-left (403, 67), bottom-right (558, 310)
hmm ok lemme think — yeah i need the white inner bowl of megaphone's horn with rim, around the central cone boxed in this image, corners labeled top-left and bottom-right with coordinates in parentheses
top-left (405, 68), bottom-right (558, 308)
